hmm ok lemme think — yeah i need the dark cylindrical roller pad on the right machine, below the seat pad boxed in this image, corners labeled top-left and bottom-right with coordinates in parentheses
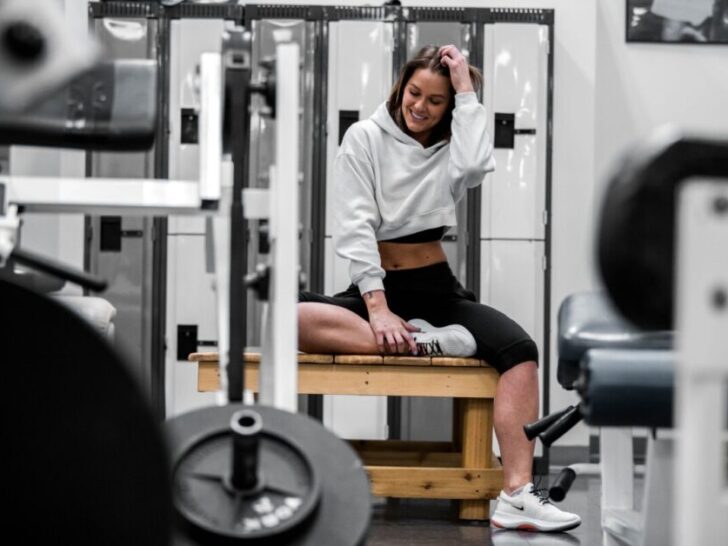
top-left (579, 349), bottom-right (675, 428)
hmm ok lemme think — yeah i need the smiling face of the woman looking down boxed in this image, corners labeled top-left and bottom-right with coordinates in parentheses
top-left (402, 68), bottom-right (450, 145)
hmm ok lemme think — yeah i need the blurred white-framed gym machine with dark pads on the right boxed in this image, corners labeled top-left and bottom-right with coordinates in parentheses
top-left (526, 129), bottom-right (728, 546)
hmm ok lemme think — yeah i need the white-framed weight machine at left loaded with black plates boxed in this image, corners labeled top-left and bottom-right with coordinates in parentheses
top-left (0, 7), bottom-right (371, 545)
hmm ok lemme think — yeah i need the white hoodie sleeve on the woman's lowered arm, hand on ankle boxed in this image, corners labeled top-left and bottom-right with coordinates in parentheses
top-left (333, 147), bottom-right (385, 294)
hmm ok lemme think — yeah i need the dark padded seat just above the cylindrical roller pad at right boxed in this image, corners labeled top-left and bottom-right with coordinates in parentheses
top-left (557, 292), bottom-right (673, 389)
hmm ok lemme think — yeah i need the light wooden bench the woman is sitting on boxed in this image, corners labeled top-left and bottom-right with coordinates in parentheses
top-left (189, 353), bottom-right (503, 520)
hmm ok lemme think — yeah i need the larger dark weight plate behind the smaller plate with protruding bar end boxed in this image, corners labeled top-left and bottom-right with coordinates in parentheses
top-left (167, 404), bottom-right (371, 546)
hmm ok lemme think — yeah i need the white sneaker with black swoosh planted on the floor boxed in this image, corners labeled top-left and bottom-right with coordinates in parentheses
top-left (490, 483), bottom-right (581, 531)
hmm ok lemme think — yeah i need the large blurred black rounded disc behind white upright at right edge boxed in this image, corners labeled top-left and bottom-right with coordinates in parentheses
top-left (597, 130), bottom-right (728, 330)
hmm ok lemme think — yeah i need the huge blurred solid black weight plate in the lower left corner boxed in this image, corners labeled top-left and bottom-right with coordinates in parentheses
top-left (0, 281), bottom-right (172, 546)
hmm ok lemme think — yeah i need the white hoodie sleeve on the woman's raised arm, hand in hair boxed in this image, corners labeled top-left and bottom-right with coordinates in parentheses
top-left (448, 92), bottom-right (495, 202)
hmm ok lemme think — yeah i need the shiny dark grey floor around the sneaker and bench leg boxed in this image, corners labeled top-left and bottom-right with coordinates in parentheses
top-left (367, 470), bottom-right (642, 546)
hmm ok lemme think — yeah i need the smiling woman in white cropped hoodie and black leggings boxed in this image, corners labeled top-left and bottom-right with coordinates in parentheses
top-left (299, 45), bottom-right (581, 531)
